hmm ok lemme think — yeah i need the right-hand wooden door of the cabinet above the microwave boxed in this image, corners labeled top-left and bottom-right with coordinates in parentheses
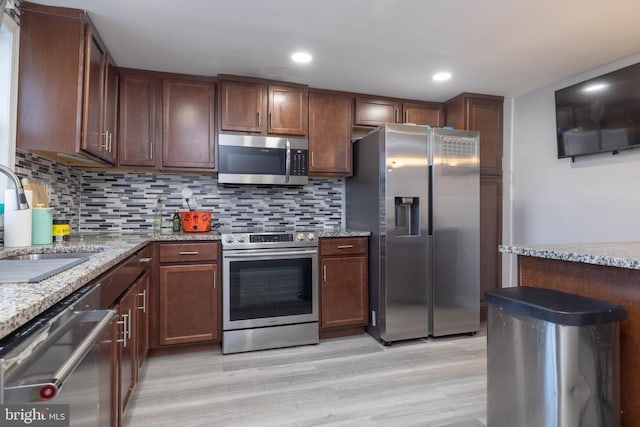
top-left (268, 85), bottom-right (309, 136)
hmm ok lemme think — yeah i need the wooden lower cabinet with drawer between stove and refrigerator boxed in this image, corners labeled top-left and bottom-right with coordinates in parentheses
top-left (319, 237), bottom-right (369, 336)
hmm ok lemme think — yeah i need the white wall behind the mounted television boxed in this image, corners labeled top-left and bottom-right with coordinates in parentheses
top-left (503, 54), bottom-right (640, 285)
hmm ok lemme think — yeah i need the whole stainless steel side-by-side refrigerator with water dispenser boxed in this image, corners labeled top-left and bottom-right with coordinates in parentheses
top-left (346, 124), bottom-right (480, 343)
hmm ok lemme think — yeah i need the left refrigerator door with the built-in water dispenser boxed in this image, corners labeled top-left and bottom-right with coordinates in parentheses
top-left (380, 124), bottom-right (430, 342)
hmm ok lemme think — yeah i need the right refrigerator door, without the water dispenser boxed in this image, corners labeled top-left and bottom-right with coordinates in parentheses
top-left (431, 129), bottom-right (480, 336)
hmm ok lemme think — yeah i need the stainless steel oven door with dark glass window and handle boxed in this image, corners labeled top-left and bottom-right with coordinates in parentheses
top-left (222, 248), bottom-right (318, 331)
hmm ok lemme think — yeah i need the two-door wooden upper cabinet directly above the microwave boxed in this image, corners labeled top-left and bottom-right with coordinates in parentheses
top-left (218, 76), bottom-right (309, 137)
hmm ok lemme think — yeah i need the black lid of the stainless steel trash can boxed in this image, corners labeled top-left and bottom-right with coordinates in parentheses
top-left (484, 286), bottom-right (627, 326)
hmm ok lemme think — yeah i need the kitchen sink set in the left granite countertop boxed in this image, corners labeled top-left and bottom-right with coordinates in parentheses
top-left (0, 252), bottom-right (96, 283)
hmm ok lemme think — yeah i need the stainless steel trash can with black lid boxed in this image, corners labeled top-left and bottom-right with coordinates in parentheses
top-left (485, 286), bottom-right (627, 427)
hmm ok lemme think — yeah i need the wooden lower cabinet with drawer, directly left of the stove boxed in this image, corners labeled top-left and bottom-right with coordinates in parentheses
top-left (152, 242), bottom-right (221, 347)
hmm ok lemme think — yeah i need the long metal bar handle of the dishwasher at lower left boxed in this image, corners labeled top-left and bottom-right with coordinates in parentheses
top-left (4, 310), bottom-right (116, 401)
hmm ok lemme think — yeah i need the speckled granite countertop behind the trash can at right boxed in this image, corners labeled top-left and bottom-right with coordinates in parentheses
top-left (499, 242), bottom-right (640, 270)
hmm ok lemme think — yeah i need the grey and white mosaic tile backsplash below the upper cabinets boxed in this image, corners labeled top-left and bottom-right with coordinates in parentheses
top-left (16, 152), bottom-right (343, 231)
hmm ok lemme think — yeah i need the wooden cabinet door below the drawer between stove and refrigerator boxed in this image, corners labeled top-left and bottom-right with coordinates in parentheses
top-left (320, 257), bottom-right (368, 328)
